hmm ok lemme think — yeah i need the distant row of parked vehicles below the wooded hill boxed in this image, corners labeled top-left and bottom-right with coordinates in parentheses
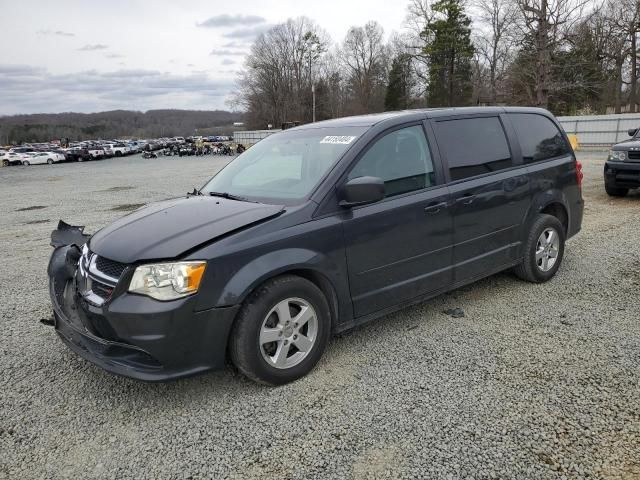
top-left (0, 136), bottom-right (235, 167)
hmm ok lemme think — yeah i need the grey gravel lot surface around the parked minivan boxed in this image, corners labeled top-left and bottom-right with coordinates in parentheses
top-left (0, 154), bottom-right (640, 479)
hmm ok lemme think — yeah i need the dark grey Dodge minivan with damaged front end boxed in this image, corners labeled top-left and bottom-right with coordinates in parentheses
top-left (48, 108), bottom-right (583, 384)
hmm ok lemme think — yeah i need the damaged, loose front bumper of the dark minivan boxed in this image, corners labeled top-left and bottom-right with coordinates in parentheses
top-left (47, 222), bottom-right (239, 382)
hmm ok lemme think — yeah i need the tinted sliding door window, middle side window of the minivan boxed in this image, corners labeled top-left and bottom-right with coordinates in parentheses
top-left (435, 117), bottom-right (513, 181)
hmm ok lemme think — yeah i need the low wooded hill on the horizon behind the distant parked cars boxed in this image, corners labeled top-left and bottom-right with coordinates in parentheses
top-left (0, 110), bottom-right (243, 145)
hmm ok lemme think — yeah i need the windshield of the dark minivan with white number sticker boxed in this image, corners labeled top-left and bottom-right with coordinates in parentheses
top-left (201, 127), bottom-right (366, 204)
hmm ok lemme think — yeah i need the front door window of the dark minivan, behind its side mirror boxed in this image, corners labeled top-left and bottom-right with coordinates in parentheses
top-left (349, 125), bottom-right (435, 197)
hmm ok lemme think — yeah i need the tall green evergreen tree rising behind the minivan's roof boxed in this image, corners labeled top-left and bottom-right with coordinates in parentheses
top-left (422, 0), bottom-right (474, 107)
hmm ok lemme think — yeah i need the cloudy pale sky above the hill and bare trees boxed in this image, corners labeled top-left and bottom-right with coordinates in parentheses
top-left (0, 0), bottom-right (406, 115)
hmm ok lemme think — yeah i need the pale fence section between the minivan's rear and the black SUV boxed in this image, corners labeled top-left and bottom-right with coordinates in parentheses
top-left (558, 113), bottom-right (640, 148)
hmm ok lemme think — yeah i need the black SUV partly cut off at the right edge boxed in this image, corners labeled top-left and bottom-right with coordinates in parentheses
top-left (604, 128), bottom-right (640, 197)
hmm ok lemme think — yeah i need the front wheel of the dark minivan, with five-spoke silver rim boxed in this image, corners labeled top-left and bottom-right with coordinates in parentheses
top-left (229, 275), bottom-right (331, 385)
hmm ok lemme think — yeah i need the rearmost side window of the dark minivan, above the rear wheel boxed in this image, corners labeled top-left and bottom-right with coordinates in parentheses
top-left (509, 113), bottom-right (571, 163)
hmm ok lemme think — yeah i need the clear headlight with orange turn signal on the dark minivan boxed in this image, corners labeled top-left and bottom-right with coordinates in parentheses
top-left (129, 261), bottom-right (207, 300)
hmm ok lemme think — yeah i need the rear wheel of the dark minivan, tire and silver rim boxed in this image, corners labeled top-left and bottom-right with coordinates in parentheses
top-left (514, 215), bottom-right (565, 283)
